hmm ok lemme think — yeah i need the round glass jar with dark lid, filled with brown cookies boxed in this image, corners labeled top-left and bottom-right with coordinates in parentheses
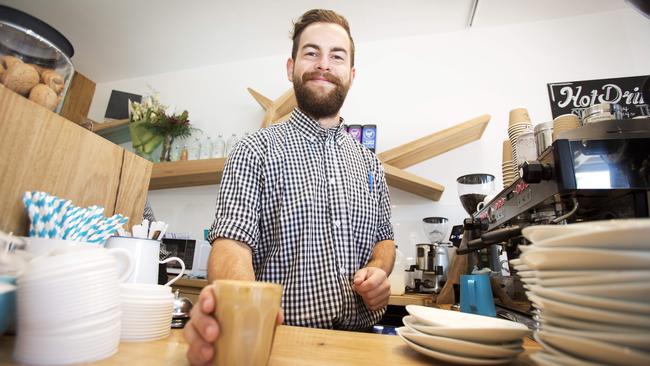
top-left (0, 5), bottom-right (74, 113)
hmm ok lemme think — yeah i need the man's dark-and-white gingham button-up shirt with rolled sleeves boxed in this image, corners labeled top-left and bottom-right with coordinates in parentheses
top-left (209, 109), bottom-right (393, 329)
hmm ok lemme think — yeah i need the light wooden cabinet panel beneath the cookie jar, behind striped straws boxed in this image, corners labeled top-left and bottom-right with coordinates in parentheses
top-left (0, 85), bottom-right (152, 235)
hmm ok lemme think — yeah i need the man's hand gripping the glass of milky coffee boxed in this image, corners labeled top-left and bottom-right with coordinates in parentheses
top-left (184, 285), bottom-right (284, 366)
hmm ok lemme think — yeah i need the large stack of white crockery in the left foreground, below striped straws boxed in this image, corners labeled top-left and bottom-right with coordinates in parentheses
top-left (14, 247), bottom-right (122, 365)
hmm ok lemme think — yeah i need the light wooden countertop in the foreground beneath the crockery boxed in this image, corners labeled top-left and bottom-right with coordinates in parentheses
top-left (0, 325), bottom-right (541, 366)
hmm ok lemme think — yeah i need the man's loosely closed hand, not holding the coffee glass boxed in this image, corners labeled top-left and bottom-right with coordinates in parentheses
top-left (352, 267), bottom-right (390, 311)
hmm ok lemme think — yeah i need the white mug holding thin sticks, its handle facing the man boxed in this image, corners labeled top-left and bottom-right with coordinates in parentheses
top-left (106, 236), bottom-right (185, 286)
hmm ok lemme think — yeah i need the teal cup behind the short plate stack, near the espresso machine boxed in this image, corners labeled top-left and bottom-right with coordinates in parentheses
top-left (460, 274), bottom-right (497, 317)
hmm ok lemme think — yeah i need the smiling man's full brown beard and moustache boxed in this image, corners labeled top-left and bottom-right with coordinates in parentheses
top-left (293, 71), bottom-right (350, 119)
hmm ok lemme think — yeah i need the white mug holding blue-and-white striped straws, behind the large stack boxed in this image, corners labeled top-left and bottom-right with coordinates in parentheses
top-left (25, 237), bottom-right (135, 282)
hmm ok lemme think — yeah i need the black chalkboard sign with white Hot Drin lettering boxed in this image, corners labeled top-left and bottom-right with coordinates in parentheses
top-left (547, 75), bottom-right (650, 118)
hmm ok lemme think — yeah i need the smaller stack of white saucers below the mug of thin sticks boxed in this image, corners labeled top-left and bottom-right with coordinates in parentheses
top-left (120, 283), bottom-right (174, 341)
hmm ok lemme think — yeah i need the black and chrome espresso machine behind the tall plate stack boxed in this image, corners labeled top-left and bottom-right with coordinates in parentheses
top-left (450, 118), bottom-right (650, 310)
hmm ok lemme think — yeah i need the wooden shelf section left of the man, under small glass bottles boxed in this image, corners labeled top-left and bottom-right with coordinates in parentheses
top-left (149, 158), bottom-right (226, 190)
